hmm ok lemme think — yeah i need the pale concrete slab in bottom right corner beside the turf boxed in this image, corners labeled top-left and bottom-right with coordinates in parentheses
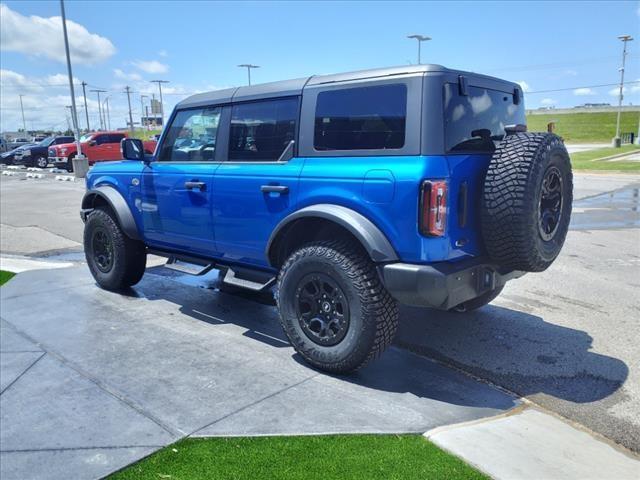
top-left (424, 407), bottom-right (640, 480)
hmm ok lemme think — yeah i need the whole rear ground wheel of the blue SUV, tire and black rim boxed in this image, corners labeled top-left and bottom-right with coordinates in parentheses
top-left (276, 241), bottom-right (398, 373)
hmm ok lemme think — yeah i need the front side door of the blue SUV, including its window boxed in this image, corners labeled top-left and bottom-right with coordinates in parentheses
top-left (140, 107), bottom-right (221, 256)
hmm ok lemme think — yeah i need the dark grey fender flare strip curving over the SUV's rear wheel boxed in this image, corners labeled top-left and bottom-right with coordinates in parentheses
top-left (265, 203), bottom-right (399, 262)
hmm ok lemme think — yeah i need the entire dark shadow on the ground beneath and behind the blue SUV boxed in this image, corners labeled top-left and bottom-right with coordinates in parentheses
top-left (139, 267), bottom-right (628, 409)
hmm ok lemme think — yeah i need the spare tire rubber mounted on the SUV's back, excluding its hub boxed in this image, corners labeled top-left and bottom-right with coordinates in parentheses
top-left (481, 133), bottom-right (573, 272)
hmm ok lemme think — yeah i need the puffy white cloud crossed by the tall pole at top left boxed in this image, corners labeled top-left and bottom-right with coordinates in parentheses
top-left (0, 4), bottom-right (116, 65)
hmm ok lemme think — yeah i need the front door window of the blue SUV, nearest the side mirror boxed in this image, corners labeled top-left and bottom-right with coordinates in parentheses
top-left (158, 107), bottom-right (222, 162)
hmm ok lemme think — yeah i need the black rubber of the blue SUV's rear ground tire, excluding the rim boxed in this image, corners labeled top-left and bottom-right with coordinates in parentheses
top-left (276, 240), bottom-right (398, 373)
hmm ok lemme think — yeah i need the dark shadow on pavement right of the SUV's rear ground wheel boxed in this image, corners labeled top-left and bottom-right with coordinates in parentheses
top-left (396, 305), bottom-right (629, 403)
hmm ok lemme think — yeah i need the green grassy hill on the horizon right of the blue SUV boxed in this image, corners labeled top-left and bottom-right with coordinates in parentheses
top-left (527, 112), bottom-right (640, 143)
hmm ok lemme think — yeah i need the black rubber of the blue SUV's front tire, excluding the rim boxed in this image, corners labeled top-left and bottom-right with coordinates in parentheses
top-left (84, 208), bottom-right (147, 290)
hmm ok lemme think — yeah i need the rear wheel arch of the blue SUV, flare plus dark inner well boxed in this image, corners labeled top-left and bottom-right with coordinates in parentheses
top-left (265, 204), bottom-right (399, 268)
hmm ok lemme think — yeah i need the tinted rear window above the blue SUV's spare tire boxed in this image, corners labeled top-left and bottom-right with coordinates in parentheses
top-left (444, 83), bottom-right (526, 153)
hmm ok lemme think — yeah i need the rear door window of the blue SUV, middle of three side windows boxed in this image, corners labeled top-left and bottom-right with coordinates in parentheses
top-left (229, 98), bottom-right (298, 162)
